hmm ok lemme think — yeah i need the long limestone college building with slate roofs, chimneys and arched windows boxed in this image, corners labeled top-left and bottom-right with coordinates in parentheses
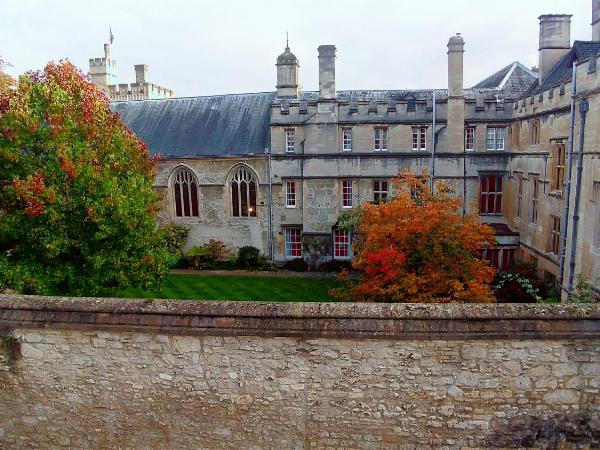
top-left (101, 0), bottom-right (600, 298)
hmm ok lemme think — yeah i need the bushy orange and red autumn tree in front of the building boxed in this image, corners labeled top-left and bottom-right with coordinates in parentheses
top-left (334, 172), bottom-right (495, 303)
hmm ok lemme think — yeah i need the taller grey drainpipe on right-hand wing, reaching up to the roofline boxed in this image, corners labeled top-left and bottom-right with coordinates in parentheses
top-left (557, 64), bottom-right (577, 301)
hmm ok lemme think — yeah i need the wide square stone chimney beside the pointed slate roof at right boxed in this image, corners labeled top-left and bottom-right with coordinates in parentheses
top-left (538, 14), bottom-right (571, 83)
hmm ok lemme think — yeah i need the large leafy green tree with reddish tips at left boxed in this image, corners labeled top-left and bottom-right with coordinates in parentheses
top-left (0, 62), bottom-right (175, 295)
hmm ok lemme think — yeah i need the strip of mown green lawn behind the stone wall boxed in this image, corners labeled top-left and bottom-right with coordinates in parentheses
top-left (119, 275), bottom-right (339, 302)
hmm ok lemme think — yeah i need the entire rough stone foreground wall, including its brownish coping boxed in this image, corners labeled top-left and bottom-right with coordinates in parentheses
top-left (0, 296), bottom-right (600, 449)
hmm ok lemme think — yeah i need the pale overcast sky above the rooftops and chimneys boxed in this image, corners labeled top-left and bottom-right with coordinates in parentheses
top-left (0, 0), bottom-right (592, 96)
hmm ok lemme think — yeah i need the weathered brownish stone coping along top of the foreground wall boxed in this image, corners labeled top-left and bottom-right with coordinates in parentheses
top-left (0, 295), bottom-right (600, 340)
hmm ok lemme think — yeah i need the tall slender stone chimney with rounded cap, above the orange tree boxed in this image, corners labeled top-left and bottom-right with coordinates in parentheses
top-left (447, 33), bottom-right (465, 153)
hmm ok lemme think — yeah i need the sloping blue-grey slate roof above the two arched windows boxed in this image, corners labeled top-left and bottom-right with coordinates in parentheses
top-left (110, 92), bottom-right (276, 156)
